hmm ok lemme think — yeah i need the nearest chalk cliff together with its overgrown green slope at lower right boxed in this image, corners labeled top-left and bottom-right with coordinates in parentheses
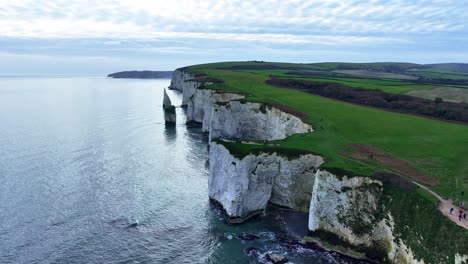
top-left (309, 170), bottom-right (468, 263)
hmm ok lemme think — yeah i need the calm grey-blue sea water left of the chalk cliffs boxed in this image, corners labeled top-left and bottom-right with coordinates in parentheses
top-left (0, 77), bottom-right (356, 263)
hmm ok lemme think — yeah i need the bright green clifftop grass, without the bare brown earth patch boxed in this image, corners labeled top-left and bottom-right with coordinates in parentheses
top-left (185, 63), bottom-right (468, 202)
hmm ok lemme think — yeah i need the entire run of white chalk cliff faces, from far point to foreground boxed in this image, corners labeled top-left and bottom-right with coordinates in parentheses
top-left (170, 70), bottom-right (468, 263)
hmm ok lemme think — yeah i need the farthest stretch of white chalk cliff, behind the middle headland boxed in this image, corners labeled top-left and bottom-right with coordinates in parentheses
top-left (170, 70), bottom-right (312, 140)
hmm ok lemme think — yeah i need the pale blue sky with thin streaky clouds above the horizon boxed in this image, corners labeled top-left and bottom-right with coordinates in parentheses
top-left (0, 0), bottom-right (468, 74)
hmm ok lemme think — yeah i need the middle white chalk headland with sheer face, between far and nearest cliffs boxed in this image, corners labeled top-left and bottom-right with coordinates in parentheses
top-left (208, 142), bottom-right (323, 222)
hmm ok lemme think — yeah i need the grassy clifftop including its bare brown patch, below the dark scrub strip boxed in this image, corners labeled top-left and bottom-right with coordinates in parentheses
top-left (184, 62), bottom-right (468, 204)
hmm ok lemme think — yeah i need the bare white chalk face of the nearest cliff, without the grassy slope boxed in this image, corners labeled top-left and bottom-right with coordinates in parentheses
top-left (309, 171), bottom-right (423, 263)
